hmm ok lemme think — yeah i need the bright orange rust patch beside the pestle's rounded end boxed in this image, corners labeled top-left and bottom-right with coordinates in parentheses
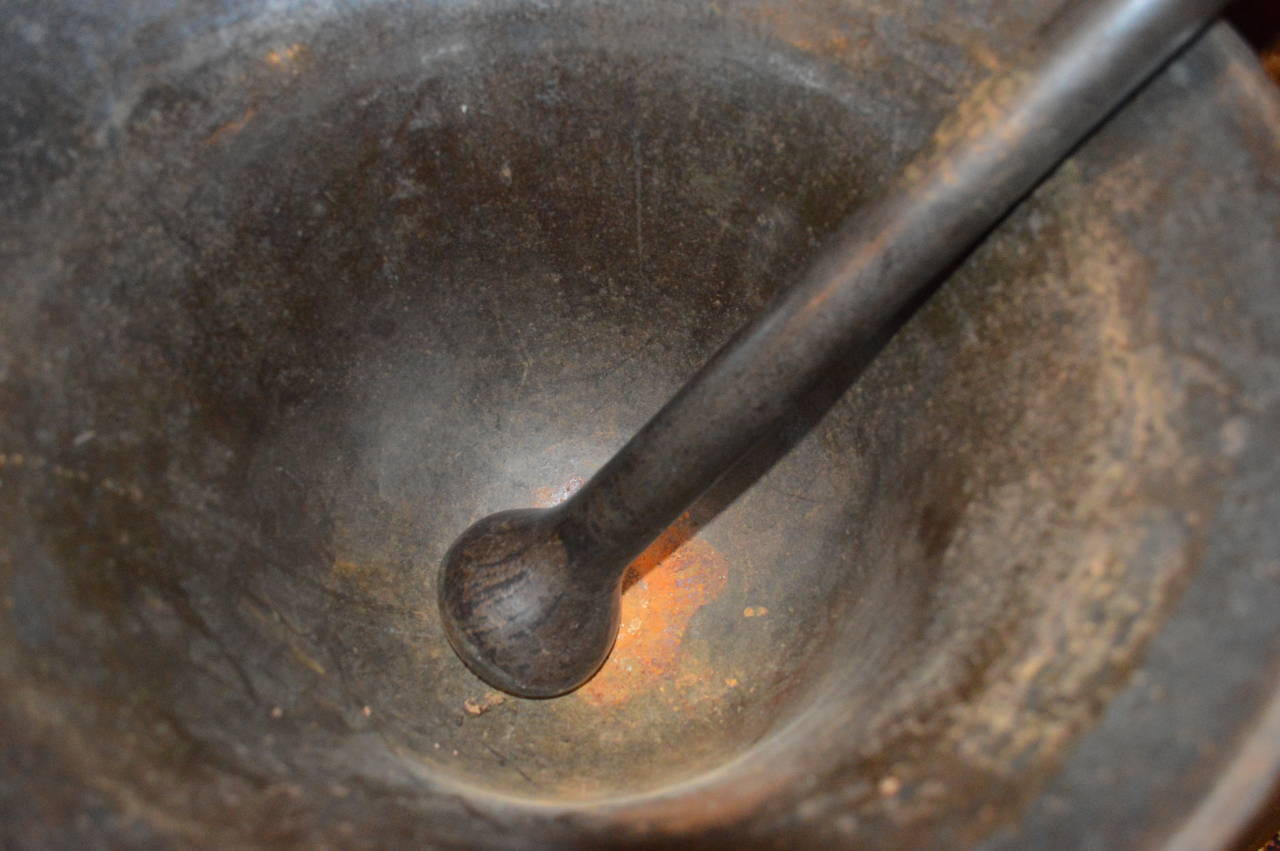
top-left (575, 517), bottom-right (728, 706)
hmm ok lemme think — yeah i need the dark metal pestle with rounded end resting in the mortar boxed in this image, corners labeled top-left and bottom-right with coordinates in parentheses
top-left (439, 0), bottom-right (1225, 697)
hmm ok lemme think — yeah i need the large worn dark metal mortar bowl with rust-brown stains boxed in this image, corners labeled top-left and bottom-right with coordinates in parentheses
top-left (0, 0), bottom-right (1280, 848)
